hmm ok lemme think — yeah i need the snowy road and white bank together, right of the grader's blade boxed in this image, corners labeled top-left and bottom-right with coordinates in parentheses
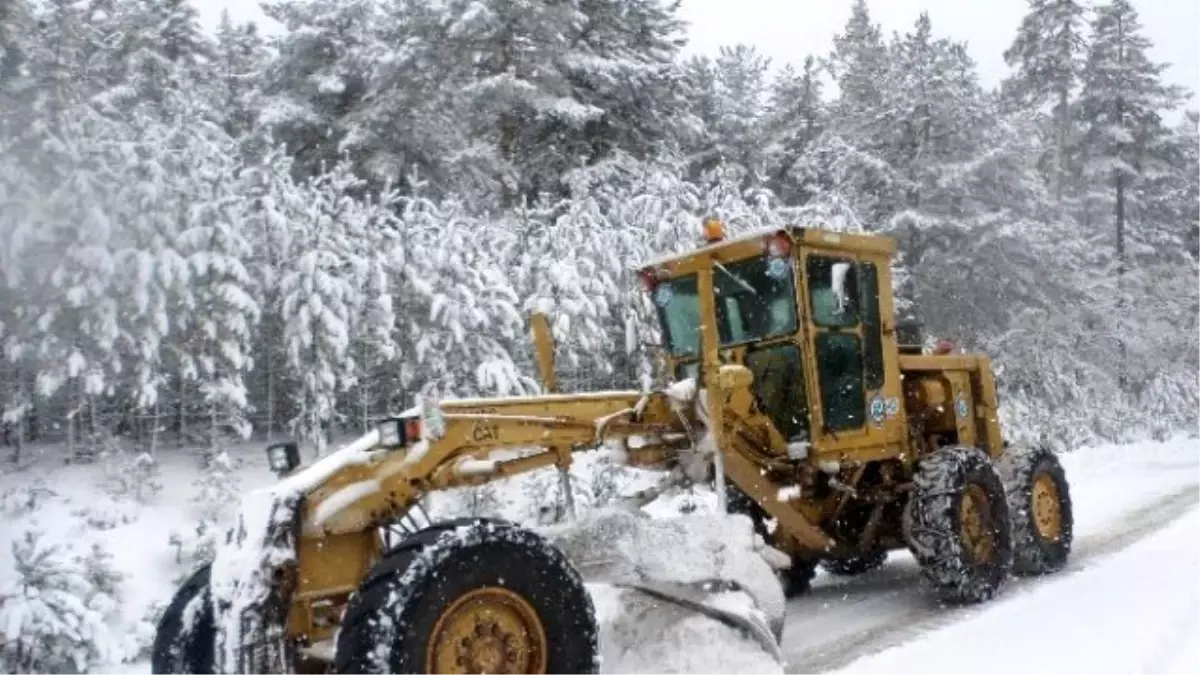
top-left (784, 438), bottom-right (1200, 675)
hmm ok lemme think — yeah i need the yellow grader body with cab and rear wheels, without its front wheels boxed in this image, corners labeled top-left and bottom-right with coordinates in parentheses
top-left (152, 222), bottom-right (1070, 673)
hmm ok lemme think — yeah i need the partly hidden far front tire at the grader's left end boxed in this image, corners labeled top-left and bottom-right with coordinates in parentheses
top-left (150, 565), bottom-right (216, 675)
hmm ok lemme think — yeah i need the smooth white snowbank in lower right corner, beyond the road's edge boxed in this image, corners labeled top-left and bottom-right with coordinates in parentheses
top-left (825, 507), bottom-right (1200, 675)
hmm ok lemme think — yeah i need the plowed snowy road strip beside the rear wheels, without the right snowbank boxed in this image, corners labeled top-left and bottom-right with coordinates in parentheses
top-left (784, 447), bottom-right (1200, 675)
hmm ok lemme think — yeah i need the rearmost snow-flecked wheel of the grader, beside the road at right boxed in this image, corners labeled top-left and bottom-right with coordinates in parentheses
top-left (998, 447), bottom-right (1075, 577)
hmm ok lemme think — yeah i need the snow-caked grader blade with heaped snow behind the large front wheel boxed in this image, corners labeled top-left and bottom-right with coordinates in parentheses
top-left (541, 509), bottom-right (785, 675)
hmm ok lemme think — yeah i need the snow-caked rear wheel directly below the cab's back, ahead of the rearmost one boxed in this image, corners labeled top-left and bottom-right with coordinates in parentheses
top-left (906, 446), bottom-right (1013, 604)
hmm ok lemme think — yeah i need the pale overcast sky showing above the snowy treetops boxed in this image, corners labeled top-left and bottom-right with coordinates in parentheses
top-left (194, 0), bottom-right (1200, 108)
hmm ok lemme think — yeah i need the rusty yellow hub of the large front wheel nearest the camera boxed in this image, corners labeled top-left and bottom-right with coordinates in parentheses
top-left (425, 586), bottom-right (547, 675)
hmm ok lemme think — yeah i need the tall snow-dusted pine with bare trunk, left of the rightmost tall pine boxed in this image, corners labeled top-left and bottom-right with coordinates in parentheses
top-left (1002, 0), bottom-right (1088, 201)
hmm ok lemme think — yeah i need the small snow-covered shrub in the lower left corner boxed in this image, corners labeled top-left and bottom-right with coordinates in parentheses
top-left (0, 531), bottom-right (120, 675)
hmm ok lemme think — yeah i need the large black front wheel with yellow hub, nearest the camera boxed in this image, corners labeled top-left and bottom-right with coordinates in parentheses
top-left (335, 519), bottom-right (599, 675)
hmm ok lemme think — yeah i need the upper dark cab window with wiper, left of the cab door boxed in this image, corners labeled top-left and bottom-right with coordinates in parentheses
top-left (713, 256), bottom-right (797, 346)
